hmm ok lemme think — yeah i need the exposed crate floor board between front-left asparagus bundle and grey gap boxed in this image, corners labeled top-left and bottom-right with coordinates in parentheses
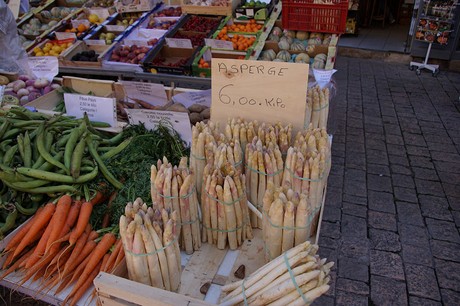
top-left (179, 244), bottom-right (227, 300)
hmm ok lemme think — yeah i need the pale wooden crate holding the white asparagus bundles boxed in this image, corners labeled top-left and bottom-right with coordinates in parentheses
top-left (94, 187), bottom-right (327, 306)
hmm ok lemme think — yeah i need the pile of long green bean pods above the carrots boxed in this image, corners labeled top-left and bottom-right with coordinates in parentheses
top-left (0, 107), bottom-right (131, 235)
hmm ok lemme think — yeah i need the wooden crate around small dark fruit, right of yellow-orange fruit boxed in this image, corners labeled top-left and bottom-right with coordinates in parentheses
top-left (59, 40), bottom-right (110, 68)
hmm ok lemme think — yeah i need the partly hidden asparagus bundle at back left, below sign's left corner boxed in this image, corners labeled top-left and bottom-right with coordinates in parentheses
top-left (190, 121), bottom-right (220, 201)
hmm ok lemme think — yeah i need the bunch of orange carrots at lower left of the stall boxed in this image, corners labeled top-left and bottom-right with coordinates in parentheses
top-left (0, 194), bottom-right (124, 305)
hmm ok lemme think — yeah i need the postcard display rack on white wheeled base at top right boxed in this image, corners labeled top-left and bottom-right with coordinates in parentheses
top-left (409, 0), bottom-right (458, 76)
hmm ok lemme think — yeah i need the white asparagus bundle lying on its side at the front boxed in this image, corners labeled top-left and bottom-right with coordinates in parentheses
top-left (220, 242), bottom-right (334, 306)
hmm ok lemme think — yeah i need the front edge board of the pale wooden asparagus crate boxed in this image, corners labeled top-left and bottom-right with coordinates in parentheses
top-left (94, 273), bottom-right (215, 306)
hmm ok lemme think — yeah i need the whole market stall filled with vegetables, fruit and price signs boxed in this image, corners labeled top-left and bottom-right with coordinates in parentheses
top-left (0, 0), bottom-right (341, 305)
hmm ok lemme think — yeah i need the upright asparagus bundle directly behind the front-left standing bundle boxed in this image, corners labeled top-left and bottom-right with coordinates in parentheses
top-left (150, 157), bottom-right (201, 254)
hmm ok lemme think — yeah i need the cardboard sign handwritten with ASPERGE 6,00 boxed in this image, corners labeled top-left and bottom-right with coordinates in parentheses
top-left (211, 58), bottom-right (309, 132)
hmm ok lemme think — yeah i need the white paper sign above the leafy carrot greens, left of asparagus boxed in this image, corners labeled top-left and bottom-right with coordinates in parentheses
top-left (125, 109), bottom-right (192, 145)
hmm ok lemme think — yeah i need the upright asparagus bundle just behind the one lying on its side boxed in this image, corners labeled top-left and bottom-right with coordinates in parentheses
top-left (262, 184), bottom-right (319, 262)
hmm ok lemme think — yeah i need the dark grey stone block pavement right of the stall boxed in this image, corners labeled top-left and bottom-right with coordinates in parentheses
top-left (314, 57), bottom-right (460, 306)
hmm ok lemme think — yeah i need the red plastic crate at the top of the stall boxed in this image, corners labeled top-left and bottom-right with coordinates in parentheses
top-left (282, 0), bottom-right (348, 34)
